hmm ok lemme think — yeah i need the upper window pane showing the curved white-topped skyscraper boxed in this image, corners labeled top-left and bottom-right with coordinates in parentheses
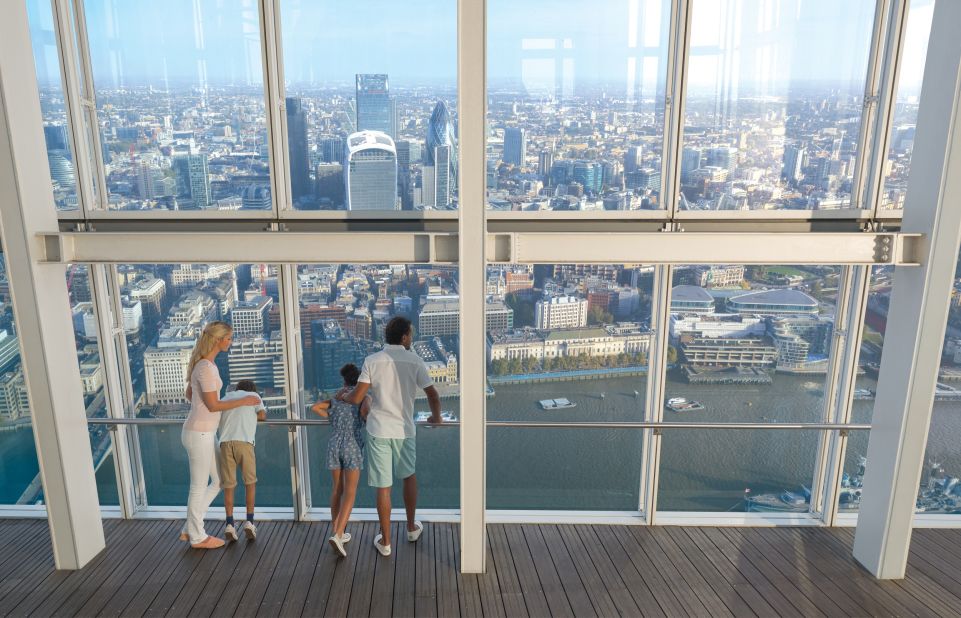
top-left (280, 0), bottom-right (458, 210)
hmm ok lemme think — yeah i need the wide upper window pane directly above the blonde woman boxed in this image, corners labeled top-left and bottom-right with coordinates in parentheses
top-left (84, 0), bottom-right (271, 212)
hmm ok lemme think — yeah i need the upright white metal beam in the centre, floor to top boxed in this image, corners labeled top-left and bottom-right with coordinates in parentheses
top-left (457, 0), bottom-right (487, 573)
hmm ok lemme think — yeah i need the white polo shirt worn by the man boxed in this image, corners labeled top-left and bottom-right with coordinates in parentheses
top-left (358, 344), bottom-right (434, 438)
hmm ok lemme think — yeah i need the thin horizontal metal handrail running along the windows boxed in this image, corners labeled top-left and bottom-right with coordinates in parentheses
top-left (87, 418), bottom-right (871, 431)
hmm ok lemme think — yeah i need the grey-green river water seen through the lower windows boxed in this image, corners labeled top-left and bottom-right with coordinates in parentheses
top-left (0, 375), bottom-right (961, 511)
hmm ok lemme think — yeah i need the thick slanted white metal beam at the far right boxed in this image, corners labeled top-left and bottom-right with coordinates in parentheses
top-left (854, 2), bottom-right (961, 579)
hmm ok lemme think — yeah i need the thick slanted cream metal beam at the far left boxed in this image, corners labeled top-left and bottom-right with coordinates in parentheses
top-left (0, 2), bottom-right (104, 569)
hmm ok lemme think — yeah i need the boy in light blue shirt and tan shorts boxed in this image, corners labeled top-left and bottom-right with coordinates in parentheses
top-left (217, 380), bottom-right (267, 541)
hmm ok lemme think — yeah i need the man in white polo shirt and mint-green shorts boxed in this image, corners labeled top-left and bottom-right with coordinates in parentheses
top-left (339, 317), bottom-right (441, 556)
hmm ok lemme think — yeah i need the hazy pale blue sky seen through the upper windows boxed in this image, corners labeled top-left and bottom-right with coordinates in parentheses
top-left (28, 0), bottom-right (930, 94)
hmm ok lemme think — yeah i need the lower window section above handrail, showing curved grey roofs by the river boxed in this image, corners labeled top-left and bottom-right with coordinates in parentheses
top-left (664, 264), bottom-right (841, 422)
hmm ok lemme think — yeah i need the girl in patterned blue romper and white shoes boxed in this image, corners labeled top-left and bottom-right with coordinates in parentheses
top-left (311, 363), bottom-right (370, 557)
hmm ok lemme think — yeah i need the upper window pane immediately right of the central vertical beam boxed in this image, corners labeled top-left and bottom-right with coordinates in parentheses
top-left (487, 0), bottom-right (671, 211)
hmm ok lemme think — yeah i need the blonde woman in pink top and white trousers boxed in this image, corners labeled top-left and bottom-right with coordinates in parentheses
top-left (180, 322), bottom-right (260, 549)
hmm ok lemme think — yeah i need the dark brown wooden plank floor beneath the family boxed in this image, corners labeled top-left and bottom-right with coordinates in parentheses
top-left (0, 520), bottom-right (961, 618)
